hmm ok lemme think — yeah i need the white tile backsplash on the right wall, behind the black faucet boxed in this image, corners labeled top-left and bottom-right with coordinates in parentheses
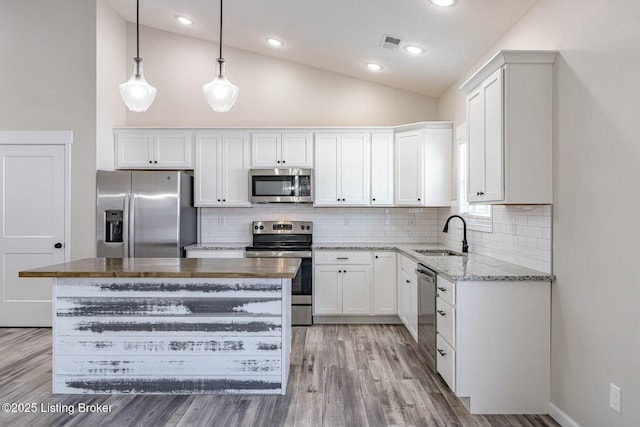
top-left (438, 205), bottom-right (552, 273)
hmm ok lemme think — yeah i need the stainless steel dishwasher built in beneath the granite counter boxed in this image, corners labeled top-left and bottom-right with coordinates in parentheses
top-left (416, 264), bottom-right (437, 373)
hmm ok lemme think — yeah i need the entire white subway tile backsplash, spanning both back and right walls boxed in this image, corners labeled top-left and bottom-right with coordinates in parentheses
top-left (199, 204), bottom-right (552, 273)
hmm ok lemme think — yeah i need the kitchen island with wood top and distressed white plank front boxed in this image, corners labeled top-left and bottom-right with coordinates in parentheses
top-left (20, 258), bottom-right (300, 394)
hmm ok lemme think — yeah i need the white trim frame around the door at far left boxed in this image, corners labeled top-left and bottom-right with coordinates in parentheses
top-left (0, 130), bottom-right (73, 262)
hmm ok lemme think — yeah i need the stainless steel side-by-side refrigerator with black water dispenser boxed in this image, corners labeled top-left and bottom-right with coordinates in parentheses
top-left (96, 171), bottom-right (197, 258)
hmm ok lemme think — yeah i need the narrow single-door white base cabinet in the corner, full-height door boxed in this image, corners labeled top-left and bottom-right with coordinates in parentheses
top-left (373, 252), bottom-right (398, 315)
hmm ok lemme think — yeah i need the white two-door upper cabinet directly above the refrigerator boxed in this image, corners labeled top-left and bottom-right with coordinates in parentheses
top-left (114, 129), bottom-right (193, 169)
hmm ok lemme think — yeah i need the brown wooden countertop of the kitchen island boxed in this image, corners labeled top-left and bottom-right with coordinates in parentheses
top-left (19, 258), bottom-right (300, 279)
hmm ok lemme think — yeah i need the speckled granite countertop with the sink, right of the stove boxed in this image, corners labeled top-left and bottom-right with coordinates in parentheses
top-left (313, 243), bottom-right (555, 282)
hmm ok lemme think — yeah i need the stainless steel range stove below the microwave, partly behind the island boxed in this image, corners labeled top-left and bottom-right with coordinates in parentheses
top-left (245, 221), bottom-right (313, 325)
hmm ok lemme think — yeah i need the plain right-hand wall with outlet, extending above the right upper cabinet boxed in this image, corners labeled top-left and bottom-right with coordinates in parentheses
top-left (438, 0), bottom-right (640, 427)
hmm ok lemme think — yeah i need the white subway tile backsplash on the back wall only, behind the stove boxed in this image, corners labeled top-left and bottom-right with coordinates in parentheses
top-left (200, 204), bottom-right (438, 243)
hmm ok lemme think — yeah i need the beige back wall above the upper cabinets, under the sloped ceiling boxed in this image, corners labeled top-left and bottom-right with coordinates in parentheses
top-left (126, 24), bottom-right (437, 127)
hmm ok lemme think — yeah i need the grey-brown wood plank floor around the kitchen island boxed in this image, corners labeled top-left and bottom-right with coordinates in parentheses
top-left (0, 325), bottom-right (558, 427)
